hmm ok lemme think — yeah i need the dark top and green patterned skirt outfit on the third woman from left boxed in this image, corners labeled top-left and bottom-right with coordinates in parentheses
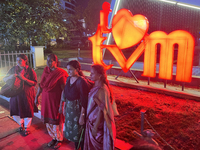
top-left (64, 77), bottom-right (89, 142)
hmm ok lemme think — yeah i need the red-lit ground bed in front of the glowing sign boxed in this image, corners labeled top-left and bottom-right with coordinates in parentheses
top-left (112, 86), bottom-right (200, 150)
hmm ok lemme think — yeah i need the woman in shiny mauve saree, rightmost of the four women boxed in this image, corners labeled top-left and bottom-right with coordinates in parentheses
top-left (84, 65), bottom-right (116, 150)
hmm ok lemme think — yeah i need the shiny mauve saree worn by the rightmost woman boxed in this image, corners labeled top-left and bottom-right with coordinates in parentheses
top-left (84, 85), bottom-right (116, 150)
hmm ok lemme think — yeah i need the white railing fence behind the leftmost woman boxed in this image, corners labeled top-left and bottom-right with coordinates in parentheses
top-left (0, 50), bottom-right (34, 70)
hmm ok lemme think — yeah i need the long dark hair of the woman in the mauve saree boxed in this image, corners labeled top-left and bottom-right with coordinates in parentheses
top-left (92, 64), bottom-right (113, 103)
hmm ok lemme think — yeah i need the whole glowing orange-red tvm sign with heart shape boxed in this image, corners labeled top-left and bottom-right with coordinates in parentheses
top-left (89, 2), bottom-right (194, 82)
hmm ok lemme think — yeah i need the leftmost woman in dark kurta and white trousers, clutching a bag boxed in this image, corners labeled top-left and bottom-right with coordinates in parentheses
top-left (3, 54), bottom-right (37, 136)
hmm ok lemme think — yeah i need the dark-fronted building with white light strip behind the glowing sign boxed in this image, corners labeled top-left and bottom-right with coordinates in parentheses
top-left (108, 0), bottom-right (200, 43)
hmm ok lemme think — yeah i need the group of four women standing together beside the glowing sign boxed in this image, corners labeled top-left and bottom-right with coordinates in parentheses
top-left (4, 54), bottom-right (118, 150)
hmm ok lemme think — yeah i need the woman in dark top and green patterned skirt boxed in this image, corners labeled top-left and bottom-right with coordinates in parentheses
top-left (60, 60), bottom-right (89, 149)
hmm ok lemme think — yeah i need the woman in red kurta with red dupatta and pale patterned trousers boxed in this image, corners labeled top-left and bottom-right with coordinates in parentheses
top-left (35, 54), bottom-right (68, 149)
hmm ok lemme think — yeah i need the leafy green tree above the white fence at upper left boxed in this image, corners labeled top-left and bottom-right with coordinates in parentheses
top-left (0, 0), bottom-right (67, 49)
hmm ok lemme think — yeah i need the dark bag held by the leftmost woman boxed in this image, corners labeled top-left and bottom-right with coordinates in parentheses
top-left (0, 77), bottom-right (24, 97)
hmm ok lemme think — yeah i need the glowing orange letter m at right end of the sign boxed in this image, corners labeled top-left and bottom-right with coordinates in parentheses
top-left (143, 30), bottom-right (194, 82)
